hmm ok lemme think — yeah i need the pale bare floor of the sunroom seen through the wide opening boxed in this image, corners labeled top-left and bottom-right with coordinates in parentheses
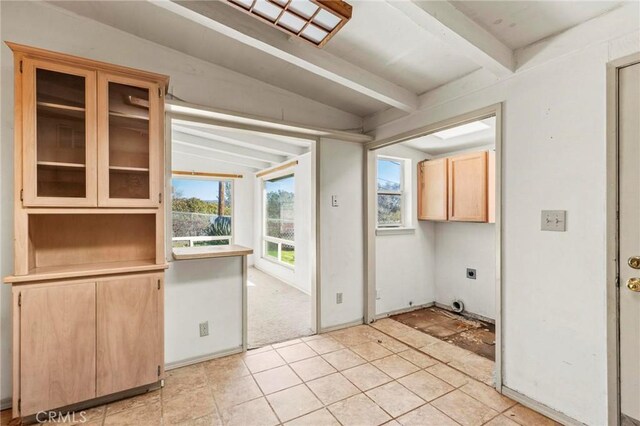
top-left (247, 268), bottom-right (313, 348)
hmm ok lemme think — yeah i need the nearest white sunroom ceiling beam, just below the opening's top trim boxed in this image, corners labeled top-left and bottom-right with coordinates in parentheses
top-left (172, 121), bottom-right (307, 157)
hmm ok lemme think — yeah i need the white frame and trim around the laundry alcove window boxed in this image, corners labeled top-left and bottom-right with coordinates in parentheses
top-left (374, 154), bottom-right (415, 230)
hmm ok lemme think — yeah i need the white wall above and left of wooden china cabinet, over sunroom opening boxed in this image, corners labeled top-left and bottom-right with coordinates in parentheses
top-left (0, 2), bottom-right (362, 401)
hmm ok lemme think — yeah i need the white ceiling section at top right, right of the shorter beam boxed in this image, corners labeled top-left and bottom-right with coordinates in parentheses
top-left (451, 0), bottom-right (623, 49)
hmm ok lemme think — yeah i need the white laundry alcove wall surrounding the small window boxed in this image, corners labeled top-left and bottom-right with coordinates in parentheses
top-left (375, 144), bottom-right (436, 315)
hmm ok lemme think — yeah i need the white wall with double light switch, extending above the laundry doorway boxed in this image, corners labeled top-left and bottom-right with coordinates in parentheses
top-left (376, 25), bottom-right (640, 425)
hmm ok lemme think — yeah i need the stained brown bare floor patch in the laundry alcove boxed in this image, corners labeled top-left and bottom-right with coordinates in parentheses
top-left (390, 306), bottom-right (496, 361)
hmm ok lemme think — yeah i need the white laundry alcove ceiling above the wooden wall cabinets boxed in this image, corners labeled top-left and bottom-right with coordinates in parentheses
top-left (402, 117), bottom-right (496, 156)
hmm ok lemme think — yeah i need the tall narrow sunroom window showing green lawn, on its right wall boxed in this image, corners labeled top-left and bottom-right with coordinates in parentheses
top-left (262, 175), bottom-right (296, 266)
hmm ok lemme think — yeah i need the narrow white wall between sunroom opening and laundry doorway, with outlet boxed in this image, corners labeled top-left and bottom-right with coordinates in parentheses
top-left (318, 139), bottom-right (364, 328)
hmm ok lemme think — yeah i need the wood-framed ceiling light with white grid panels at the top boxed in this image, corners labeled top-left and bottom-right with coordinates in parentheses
top-left (227, 0), bottom-right (352, 47)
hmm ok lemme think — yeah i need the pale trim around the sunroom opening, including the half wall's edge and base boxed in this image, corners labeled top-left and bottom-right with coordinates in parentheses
top-left (164, 110), bottom-right (322, 352)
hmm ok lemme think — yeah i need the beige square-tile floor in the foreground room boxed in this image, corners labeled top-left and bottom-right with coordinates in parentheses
top-left (2, 320), bottom-right (557, 426)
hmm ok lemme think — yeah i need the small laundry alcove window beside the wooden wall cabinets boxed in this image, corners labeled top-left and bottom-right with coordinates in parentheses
top-left (376, 156), bottom-right (410, 228)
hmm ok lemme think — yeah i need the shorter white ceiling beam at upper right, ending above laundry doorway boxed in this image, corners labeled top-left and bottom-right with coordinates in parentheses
top-left (387, 0), bottom-right (515, 77)
